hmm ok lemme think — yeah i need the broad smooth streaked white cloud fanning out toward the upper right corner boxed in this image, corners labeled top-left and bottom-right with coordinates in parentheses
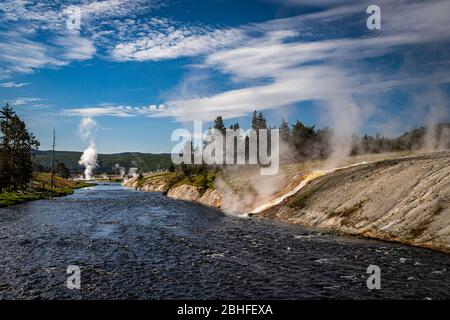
top-left (156, 1), bottom-right (450, 121)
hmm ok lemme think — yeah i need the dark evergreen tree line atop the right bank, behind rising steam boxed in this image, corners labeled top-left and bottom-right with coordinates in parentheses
top-left (169, 110), bottom-right (450, 176)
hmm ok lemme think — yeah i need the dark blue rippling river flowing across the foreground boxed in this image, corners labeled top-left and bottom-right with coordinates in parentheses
top-left (0, 185), bottom-right (450, 299)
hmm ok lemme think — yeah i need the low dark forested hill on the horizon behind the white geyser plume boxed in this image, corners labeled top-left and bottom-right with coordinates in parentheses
top-left (34, 150), bottom-right (172, 173)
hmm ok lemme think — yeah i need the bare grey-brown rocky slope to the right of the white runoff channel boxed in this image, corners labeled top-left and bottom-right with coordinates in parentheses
top-left (253, 152), bottom-right (450, 252)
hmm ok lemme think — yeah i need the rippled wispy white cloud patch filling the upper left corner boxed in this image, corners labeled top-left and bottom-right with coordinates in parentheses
top-left (0, 0), bottom-right (162, 79)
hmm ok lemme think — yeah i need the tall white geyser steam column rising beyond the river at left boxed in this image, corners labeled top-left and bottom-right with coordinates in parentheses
top-left (78, 117), bottom-right (97, 180)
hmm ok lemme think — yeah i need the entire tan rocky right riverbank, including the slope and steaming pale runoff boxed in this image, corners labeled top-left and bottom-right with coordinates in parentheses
top-left (126, 152), bottom-right (450, 252)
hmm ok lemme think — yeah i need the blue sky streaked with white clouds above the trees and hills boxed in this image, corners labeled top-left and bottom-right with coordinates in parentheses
top-left (0, 0), bottom-right (450, 153)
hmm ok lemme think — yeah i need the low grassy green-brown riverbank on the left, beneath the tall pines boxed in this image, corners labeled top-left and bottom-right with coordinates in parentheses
top-left (0, 173), bottom-right (94, 208)
